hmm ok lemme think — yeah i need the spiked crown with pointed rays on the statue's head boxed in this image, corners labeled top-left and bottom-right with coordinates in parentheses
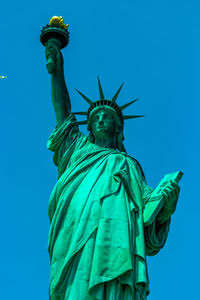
top-left (74, 77), bottom-right (144, 125)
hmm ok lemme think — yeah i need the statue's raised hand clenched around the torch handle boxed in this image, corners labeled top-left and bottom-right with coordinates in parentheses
top-left (45, 40), bottom-right (63, 74)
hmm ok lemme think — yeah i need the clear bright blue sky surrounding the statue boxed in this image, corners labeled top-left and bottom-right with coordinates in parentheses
top-left (0, 0), bottom-right (200, 300)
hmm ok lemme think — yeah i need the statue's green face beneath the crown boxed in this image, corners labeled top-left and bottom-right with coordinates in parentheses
top-left (91, 110), bottom-right (116, 138)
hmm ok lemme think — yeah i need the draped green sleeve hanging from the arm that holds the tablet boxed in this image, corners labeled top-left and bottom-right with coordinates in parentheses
top-left (143, 176), bottom-right (171, 256)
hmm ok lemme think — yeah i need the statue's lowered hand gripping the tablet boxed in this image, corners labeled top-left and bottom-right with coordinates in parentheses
top-left (157, 180), bottom-right (180, 223)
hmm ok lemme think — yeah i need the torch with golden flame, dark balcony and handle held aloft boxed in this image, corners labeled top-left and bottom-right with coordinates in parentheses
top-left (40, 16), bottom-right (69, 74)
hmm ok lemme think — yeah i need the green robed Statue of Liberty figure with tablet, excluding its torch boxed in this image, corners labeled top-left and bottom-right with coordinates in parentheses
top-left (43, 17), bottom-right (182, 300)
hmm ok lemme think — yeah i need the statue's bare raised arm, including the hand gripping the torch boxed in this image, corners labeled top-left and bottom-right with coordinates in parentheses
top-left (45, 41), bottom-right (71, 126)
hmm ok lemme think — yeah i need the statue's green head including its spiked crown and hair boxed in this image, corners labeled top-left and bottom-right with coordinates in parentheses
top-left (75, 78), bottom-right (143, 152)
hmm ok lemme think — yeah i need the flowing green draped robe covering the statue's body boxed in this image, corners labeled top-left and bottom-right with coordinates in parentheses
top-left (48, 114), bottom-right (170, 300)
